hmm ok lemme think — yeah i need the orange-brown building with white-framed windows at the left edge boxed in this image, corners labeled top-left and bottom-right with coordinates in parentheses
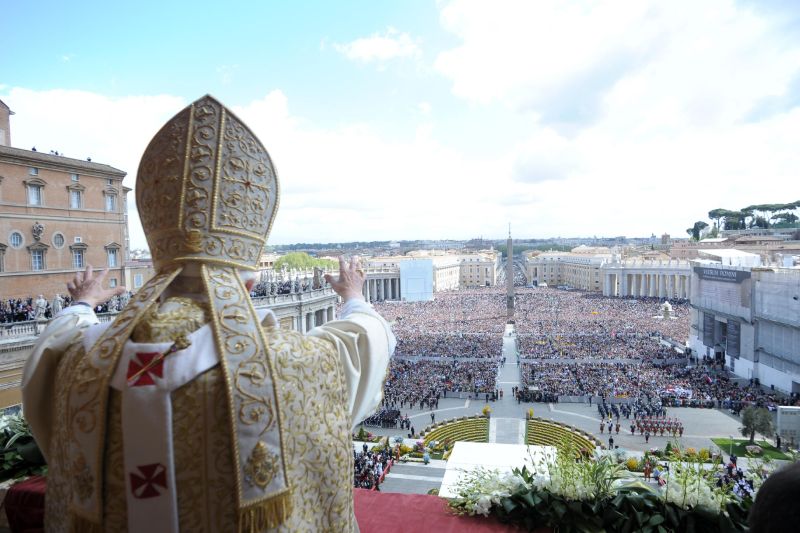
top-left (0, 97), bottom-right (130, 300)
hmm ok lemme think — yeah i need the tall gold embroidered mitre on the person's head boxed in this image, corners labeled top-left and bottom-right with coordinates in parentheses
top-left (136, 96), bottom-right (279, 270)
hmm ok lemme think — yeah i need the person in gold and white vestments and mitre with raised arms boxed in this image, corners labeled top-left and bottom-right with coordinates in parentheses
top-left (18, 96), bottom-right (395, 533)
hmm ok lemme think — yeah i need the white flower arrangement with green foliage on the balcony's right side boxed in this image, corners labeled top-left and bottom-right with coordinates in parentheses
top-left (450, 442), bottom-right (749, 532)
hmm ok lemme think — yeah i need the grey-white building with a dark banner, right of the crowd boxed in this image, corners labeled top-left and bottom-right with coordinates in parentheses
top-left (689, 257), bottom-right (800, 393)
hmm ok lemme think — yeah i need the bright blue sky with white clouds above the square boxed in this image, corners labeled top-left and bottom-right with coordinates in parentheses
top-left (0, 0), bottom-right (800, 248)
